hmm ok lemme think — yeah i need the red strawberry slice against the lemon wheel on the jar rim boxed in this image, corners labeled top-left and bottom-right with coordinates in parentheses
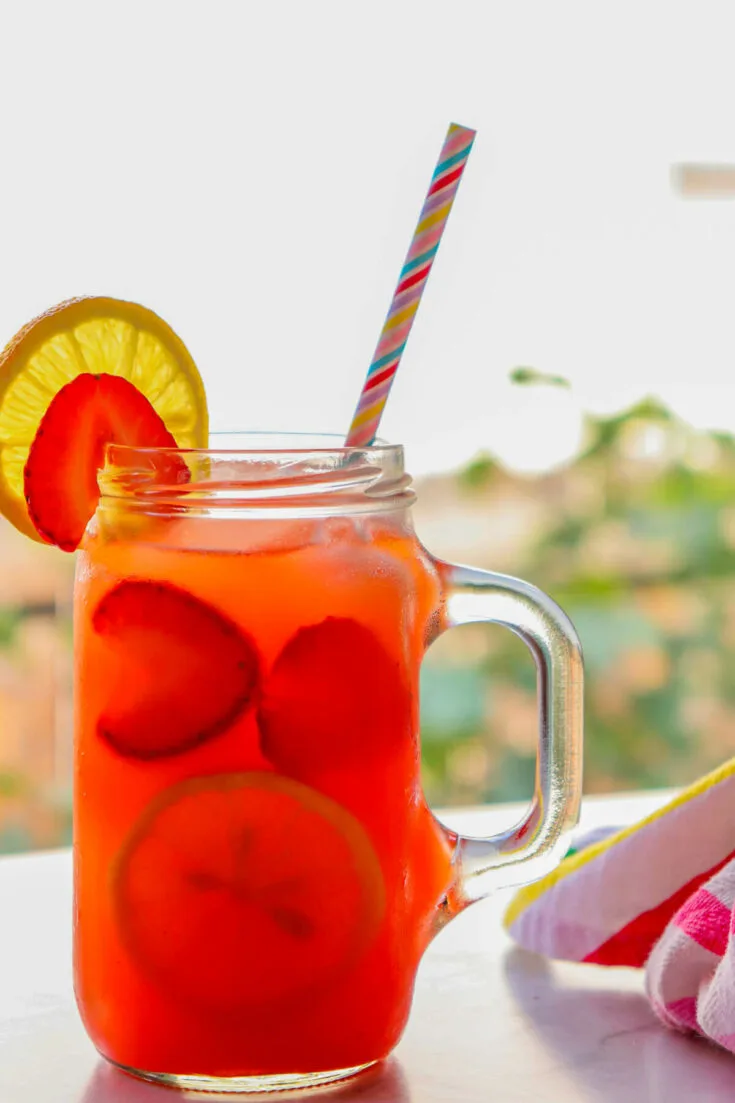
top-left (24, 372), bottom-right (188, 552)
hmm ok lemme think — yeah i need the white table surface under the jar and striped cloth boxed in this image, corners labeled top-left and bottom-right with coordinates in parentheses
top-left (0, 794), bottom-right (735, 1103)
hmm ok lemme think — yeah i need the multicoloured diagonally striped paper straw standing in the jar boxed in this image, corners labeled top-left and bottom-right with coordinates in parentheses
top-left (345, 122), bottom-right (475, 447)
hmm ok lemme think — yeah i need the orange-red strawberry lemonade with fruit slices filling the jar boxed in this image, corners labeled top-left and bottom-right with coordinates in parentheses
top-left (75, 478), bottom-right (451, 1077)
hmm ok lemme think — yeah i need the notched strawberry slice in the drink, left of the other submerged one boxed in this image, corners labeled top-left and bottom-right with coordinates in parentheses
top-left (92, 579), bottom-right (259, 759)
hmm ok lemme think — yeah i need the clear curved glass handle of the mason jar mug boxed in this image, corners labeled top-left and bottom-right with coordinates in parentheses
top-left (435, 560), bottom-right (584, 913)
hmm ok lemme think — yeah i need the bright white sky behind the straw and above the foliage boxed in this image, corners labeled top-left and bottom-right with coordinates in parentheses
top-left (0, 0), bottom-right (735, 472)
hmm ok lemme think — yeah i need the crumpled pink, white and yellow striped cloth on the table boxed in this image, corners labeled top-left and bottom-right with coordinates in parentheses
top-left (504, 759), bottom-right (735, 1052)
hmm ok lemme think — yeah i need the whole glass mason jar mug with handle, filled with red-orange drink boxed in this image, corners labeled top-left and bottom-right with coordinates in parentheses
top-left (75, 437), bottom-right (582, 1091)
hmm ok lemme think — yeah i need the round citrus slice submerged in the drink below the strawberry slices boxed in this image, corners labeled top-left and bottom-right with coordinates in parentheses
top-left (114, 773), bottom-right (385, 1013)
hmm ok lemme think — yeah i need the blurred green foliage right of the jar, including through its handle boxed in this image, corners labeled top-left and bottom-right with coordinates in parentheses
top-left (422, 392), bottom-right (735, 805)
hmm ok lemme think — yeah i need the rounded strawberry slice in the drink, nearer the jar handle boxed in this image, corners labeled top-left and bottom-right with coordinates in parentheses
top-left (258, 617), bottom-right (413, 778)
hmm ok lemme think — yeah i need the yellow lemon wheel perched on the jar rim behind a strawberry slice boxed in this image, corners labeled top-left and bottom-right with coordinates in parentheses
top-left (0, 297), bottom-right (209, 540)
